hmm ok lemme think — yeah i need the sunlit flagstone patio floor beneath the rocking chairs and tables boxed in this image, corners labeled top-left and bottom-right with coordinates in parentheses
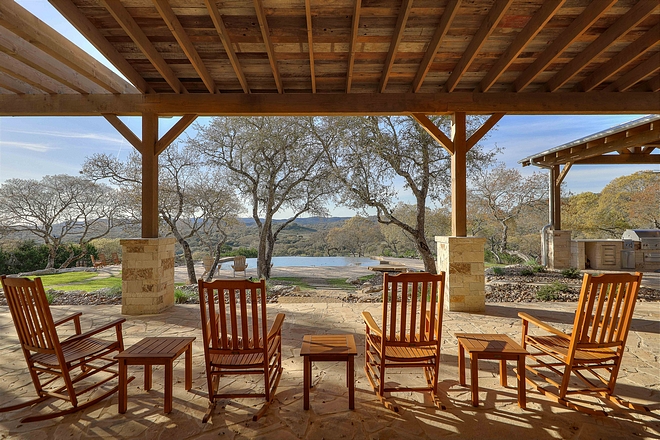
top-left (0, 303), bottom-right (660, 440)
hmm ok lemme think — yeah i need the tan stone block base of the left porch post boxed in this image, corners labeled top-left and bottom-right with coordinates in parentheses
top-left (120, 238), bottom-right (176, 315)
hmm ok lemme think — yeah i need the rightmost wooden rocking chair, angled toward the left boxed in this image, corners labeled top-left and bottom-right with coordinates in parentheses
top-left (518, 273), bottom-right (649, 415)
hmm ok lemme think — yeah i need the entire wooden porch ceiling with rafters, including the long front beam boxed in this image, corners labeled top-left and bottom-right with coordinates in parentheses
top-left (0, 0), bottom-right (660, 115)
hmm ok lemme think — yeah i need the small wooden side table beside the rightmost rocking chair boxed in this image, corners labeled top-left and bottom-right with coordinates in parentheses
top-left (456, 333), bottom-right (529, 408)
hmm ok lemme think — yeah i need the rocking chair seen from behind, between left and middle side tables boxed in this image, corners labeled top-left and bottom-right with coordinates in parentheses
top-left (199, 280), bottom-right (284, 423)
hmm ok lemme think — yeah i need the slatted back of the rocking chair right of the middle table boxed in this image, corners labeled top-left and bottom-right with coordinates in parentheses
top-left (383, 273), bottom-right (444, 347)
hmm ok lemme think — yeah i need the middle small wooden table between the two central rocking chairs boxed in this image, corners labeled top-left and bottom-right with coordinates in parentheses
top-left (300, 335), bottom-right (357, 409)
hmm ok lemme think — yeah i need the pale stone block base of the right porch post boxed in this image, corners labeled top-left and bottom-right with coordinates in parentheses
top-left (435, 237), bottom-right (486, 313)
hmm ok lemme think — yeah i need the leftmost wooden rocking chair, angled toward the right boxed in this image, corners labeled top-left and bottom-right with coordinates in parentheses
top-left (0, 276), bottom-right (127, 422)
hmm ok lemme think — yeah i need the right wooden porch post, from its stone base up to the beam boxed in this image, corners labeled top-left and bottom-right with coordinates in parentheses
top-left (451, 112), bottom-right (467, 237)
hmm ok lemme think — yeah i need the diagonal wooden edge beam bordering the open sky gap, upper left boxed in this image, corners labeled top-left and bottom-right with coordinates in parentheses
top-left (48, 0), bottom-right (152, 93)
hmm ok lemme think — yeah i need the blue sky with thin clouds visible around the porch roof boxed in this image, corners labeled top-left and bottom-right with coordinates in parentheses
top-left (0, 0), bottom-right (660, 215)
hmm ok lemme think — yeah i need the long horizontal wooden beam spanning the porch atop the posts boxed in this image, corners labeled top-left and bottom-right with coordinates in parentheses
top-left (0, 91), bottom-right (660, 116)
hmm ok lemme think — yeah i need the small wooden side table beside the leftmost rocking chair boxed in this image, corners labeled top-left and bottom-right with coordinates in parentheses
top-left (115, 337), bottom-right (195, 414)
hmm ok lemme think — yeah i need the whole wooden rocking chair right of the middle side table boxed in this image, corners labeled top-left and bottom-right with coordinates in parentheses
top-left (362, 272), bottom-right (445, 412)
